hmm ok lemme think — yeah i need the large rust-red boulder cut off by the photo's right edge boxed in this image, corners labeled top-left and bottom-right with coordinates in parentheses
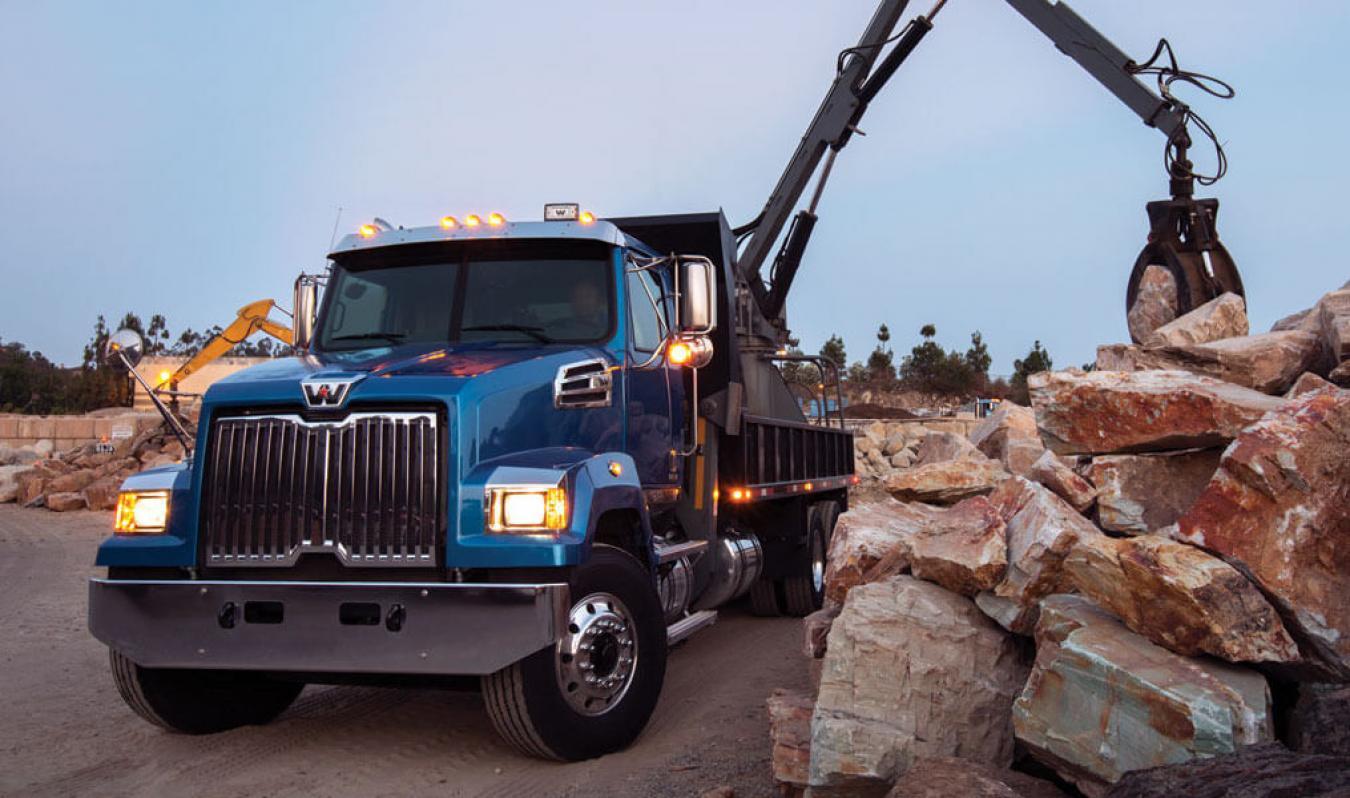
top-left (1176, 389), bottom-right (1350, 681)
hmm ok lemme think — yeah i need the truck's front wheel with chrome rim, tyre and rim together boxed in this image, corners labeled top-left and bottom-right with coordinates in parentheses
top-left (482, 546), bottom-right (666, 762)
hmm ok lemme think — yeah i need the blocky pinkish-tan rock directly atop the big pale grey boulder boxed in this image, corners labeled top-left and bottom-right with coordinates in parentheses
top-left (910, 496), bottom-right (1007, 597)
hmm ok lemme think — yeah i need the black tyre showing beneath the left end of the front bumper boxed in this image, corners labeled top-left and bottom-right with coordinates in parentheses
top-left (109, 649), bottom-right (305, 735)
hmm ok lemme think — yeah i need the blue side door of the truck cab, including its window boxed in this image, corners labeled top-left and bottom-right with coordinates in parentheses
top-left (624, 266), bottom-right (683, 486)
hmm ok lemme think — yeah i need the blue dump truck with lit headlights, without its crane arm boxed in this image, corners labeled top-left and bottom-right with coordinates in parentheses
top-left (89, 211), bottom-right (853, 759)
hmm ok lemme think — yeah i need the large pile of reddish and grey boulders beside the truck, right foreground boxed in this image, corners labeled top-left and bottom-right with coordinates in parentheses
top-left (771, 283), bottom-right (1350, 797)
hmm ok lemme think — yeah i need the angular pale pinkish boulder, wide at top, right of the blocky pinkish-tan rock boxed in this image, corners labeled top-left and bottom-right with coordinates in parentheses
top-left (976, 477), bottom-right (1102, 635)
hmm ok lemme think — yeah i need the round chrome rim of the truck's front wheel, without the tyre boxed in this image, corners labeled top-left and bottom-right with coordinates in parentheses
top-left (558, 593), bottom-right (637, 716)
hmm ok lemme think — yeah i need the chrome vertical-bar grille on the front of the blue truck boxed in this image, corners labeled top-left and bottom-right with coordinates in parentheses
top-left (201, 412), bottom-right (441, 566)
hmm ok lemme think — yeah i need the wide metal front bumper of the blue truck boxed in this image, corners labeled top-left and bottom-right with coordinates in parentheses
top-left (89, 579), bottom-right (568, 674)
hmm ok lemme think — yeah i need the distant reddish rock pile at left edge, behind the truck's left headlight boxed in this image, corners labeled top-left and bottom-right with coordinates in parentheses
top-left (0, 425), bottom-right (190, 512)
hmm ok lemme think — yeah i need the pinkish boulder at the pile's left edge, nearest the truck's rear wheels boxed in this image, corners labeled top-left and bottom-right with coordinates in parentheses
top-left (825, 500), bottom-right (932, 606)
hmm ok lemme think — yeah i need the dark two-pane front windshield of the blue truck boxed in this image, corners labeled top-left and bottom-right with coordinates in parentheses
top-left (317, 240), bottom-right (614, 351)
